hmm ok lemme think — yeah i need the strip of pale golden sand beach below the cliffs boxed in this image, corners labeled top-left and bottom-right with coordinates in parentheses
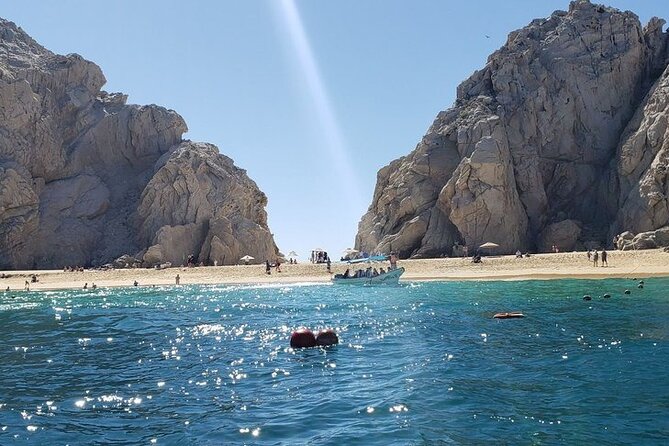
top-left (0, 249), bottom-right (669, 291)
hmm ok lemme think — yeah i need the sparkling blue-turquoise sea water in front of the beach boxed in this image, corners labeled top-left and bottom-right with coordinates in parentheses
top-left (0, 279), bottom-right (669, 445)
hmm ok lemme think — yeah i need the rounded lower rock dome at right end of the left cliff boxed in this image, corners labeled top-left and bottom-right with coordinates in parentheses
top-left (138, 142), bottom-right (277, 265)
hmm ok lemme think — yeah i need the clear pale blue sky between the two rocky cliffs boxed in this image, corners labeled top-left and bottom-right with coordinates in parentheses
top-left (0, 0), bottom-right (669, 261)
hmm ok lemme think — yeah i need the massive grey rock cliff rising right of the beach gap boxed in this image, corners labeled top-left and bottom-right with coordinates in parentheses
top-left (356, 0), bottom-right (669, 257)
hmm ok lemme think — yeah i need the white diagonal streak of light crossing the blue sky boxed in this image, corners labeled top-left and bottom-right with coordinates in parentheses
top-left (272, 0), bottom-right (365, 211)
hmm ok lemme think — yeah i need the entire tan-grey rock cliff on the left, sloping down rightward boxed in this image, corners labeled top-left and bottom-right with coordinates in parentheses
top-left (0, 19), bottom-right (278, 269)
